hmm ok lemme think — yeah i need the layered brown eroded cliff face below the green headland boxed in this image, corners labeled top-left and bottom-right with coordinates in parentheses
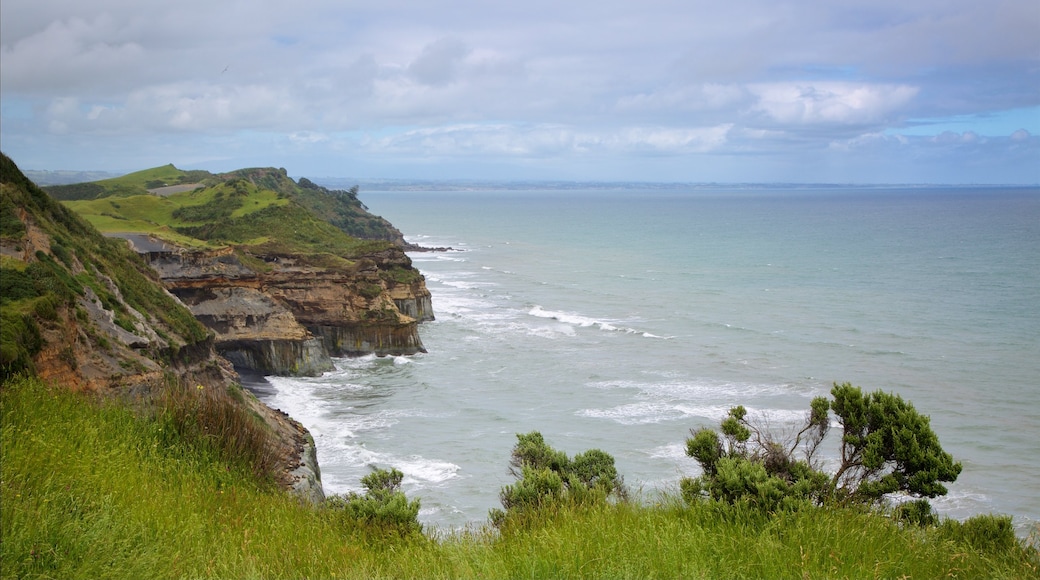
top-left (138, 239), bottom-right (434, 375)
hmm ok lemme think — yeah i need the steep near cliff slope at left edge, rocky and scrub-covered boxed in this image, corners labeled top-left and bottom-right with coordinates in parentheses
top-left (0, 155), bottom-right (323, 501)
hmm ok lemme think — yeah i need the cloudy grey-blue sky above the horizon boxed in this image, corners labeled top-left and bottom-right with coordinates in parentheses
top-left (0, 0), bottom-right (1040, 184)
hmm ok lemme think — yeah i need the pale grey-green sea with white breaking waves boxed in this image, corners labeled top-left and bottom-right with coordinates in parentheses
top-left (253, 188), bottom-right (1040, 533)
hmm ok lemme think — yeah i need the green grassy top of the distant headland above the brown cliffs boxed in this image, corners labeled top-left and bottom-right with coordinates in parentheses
top-left (54, 165), bottom-right (401, 260)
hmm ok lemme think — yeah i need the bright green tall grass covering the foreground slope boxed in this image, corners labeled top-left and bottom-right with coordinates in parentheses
top-left (0, 379), bottom-right (1040, 579)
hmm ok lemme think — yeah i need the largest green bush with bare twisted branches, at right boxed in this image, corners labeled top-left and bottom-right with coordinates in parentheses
top-left (682, 383), bottom-right (961, 509)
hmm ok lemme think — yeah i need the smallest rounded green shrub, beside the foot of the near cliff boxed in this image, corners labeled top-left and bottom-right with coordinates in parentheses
top-left (326, 469), bottom-right (422, 535)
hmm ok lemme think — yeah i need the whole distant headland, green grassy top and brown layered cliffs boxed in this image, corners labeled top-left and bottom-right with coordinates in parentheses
top-left (48, 161), bottom-right (433, 374)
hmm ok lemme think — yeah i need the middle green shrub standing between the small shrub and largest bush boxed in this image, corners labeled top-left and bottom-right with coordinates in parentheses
top-left (490, 431), bottom-right (628, 528)
